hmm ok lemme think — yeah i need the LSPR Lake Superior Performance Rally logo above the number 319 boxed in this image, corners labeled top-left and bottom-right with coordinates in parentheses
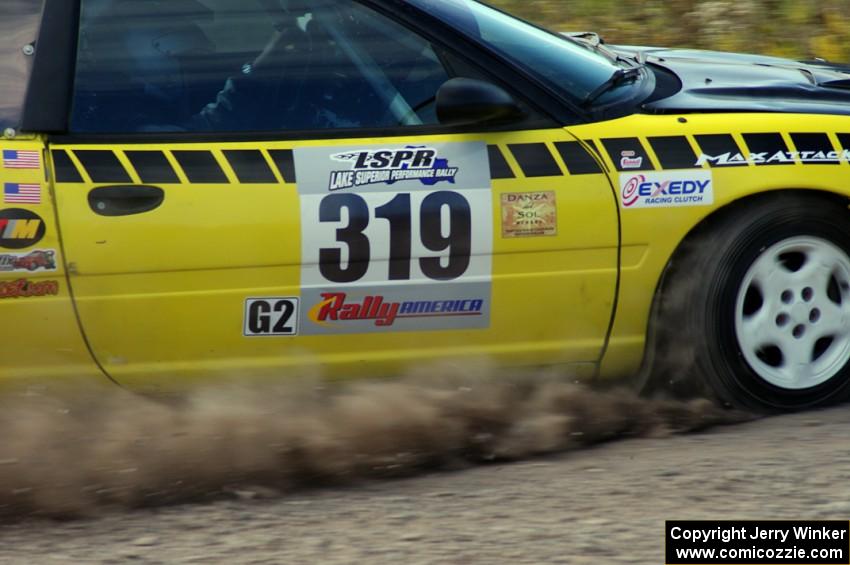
top-left (328, 146), bottom-right (458, 191)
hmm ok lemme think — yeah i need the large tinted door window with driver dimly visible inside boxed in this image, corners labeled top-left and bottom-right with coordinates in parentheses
top-left (70, 0), bottom-right (460, 133)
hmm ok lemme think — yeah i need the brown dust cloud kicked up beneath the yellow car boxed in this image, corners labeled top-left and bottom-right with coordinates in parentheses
top-left (0, 370), bottom-right (749, 521)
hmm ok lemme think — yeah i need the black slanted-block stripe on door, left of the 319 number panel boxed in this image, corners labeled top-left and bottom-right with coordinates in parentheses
top-left (53, 149), bottom-right (295, 184)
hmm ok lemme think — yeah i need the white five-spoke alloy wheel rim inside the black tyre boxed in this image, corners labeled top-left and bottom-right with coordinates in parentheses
top-left (735, 236), bottom-right (850, 390)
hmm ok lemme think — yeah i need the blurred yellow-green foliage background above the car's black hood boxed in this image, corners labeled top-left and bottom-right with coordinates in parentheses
top-left (490, 0), bottom-right (850, 62)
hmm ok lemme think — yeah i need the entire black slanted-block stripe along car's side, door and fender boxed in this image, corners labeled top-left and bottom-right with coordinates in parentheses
top-left (53, 133), bottom-right (850, 184)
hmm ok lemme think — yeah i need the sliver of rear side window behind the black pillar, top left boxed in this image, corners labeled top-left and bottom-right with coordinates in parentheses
top-left (0, 0), bottom-right (43, 133)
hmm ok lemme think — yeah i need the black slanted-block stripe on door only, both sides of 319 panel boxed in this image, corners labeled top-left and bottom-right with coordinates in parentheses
top-left (53, 141), bottom-right (603, 184)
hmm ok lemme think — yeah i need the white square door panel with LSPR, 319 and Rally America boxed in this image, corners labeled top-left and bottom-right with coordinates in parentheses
top-left (295, 142), bottom-right (493, 335)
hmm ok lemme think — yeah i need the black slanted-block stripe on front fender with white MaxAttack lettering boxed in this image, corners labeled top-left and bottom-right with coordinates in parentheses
top-left (599, 132), bottom-right (850, 172)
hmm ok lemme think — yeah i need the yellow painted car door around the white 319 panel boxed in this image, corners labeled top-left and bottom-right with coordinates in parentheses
top-left (51, 130), bottom-right (618, 386)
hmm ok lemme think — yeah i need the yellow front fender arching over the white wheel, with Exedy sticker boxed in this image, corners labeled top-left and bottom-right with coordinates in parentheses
top-left (570, 114), bottom-right (850, 377)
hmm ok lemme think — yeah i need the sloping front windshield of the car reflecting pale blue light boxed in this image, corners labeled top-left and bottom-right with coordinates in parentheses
top-left (409, 0), bottom-right (619, 102)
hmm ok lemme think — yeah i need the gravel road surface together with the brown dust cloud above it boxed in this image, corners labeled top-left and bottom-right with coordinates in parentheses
top-left (0, 366), bottom-right (850, 563)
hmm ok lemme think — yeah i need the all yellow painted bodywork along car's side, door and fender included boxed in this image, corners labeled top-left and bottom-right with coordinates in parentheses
top-left (0, 114), bottom-right (850, 387)
